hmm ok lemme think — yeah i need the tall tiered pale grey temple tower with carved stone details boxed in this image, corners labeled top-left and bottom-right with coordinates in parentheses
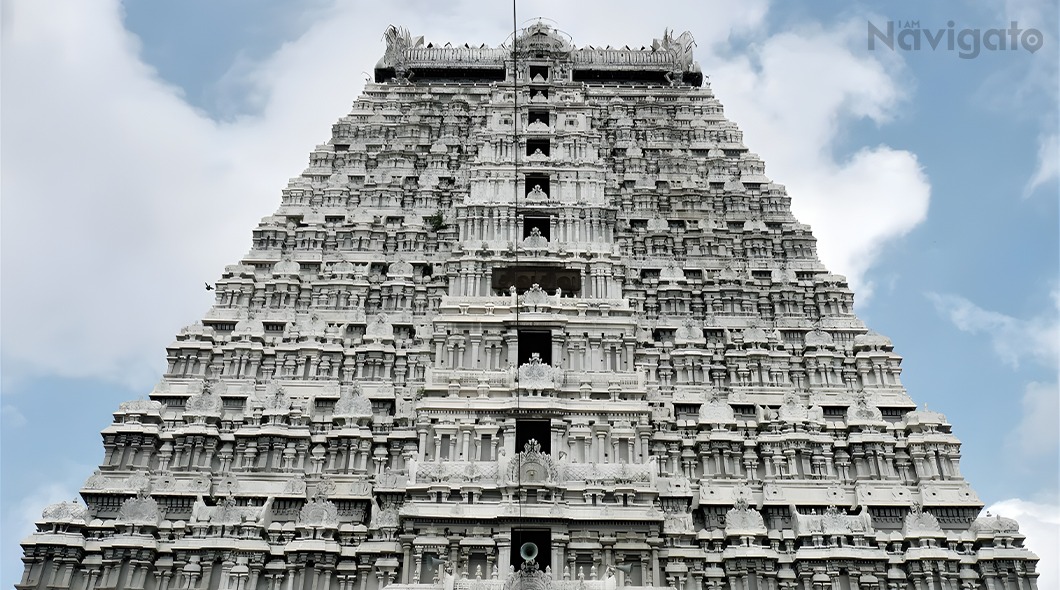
top-left (18, 23), bottom-right (1037, 590)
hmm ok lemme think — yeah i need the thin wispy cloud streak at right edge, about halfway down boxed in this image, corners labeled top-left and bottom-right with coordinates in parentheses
top-left (928, 293), bottom-right (1060, 369)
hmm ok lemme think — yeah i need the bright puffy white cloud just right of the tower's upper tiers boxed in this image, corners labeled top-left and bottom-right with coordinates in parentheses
top-left (707, 21), bottom-right (931, 300)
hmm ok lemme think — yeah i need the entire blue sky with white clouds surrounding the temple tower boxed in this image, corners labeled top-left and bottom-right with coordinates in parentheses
top-left (0, 0), bottom-right (1060, 590)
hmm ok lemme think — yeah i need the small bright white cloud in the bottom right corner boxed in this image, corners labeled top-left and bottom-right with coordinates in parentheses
top-left (986, 498), bottom-right (1060, 590)
